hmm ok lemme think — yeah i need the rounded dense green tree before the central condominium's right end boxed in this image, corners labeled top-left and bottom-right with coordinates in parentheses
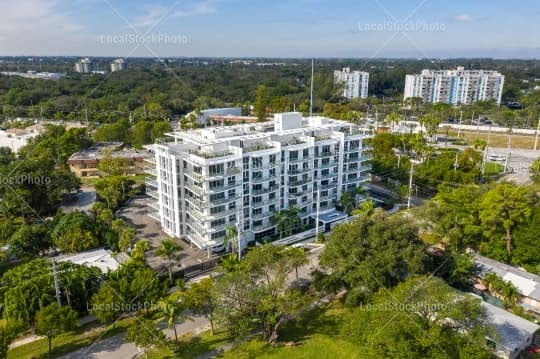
top-left (316, 212), bottom-right (429, 304)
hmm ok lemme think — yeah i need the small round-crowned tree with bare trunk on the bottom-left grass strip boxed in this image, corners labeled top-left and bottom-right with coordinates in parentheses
top-left (36, 303), bottom-right (78, 355)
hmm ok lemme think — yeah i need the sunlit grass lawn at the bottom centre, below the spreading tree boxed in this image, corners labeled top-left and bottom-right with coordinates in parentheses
top-left (217, 308), bottom-right (362, 359)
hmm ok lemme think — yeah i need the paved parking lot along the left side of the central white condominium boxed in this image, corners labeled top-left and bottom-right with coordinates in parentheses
top-left (118, 196), bottom-right (215, 273)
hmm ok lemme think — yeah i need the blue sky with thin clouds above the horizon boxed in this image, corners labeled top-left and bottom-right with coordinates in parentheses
top-left (0, 0), bottom-right (540, 58)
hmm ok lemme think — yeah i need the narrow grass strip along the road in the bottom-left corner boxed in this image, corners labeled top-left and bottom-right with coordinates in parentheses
top-left (8, 318), bottom-right (134, 359)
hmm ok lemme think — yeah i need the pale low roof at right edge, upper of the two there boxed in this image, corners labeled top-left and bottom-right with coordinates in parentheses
top-left (474, 254), bottom-right (540, 301)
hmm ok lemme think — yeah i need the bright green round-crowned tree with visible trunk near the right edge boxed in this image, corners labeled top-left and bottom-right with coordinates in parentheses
top-left (480, 183), bottom-right (536, 256)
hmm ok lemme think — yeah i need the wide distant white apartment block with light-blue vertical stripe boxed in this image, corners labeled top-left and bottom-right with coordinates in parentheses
top-left (404, 67), bottom-right (504, 105)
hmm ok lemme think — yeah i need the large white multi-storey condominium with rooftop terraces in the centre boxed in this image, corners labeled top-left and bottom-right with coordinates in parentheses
top-left (146, 112), bottom-right (372, 251)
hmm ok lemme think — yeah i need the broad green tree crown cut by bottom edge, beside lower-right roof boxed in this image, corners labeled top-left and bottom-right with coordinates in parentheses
top-left (343, 277), bottom-right (494, 359)
